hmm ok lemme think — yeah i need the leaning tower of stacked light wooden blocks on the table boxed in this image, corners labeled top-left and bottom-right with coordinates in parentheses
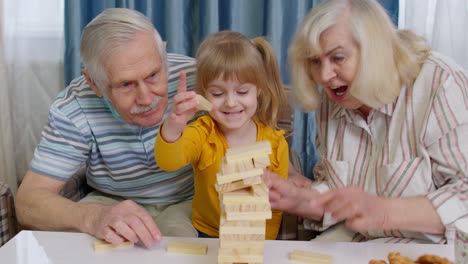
top-left (216, 141), bottom-right (272, 263)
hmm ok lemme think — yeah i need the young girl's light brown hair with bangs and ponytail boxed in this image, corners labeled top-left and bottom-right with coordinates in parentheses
top-left (196, 31), bottom-right (287, 129)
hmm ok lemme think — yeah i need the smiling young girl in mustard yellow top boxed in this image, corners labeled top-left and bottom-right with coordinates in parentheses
top-left (154, 31), bottom-right (288, 239)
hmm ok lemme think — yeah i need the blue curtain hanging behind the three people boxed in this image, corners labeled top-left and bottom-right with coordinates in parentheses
top-left (64, 0), bottom-right (398, 177)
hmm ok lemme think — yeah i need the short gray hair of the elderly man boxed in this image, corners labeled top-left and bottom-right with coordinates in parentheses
top-left (80, 8), bottom-right (166, 94)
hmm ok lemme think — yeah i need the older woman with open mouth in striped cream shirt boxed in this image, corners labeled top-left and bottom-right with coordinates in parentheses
top-left (265, 0), bottom-right (468, 243)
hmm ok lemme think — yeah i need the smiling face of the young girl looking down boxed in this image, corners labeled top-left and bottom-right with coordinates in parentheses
top-left (205, 77), bottom-right (257, 132)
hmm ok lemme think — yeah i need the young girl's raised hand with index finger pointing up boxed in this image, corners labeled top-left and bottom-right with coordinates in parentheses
top-left (161, 71), bottom-right (198, 142)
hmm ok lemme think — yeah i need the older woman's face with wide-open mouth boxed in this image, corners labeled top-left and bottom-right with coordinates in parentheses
top-left (308, 20), bottom-right (363, 110)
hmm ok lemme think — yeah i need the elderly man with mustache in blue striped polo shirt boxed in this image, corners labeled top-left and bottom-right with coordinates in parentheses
top-left (16, 8), bottom-right (197, 247)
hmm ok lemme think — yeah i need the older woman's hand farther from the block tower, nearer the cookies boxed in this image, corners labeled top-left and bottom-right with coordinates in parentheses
top-left (317, 186), bottom-right (388, 232)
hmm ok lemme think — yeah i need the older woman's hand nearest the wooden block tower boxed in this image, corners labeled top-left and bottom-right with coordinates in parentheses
top-left (263, 170), bottom-right (323, 220)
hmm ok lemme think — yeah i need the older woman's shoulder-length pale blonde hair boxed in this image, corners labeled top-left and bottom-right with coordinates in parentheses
top-left (288, 0), bottom-right (430, 111)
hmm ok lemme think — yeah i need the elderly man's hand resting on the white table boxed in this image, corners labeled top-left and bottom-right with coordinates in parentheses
top-left (89, 200), bottom-right (161, 247)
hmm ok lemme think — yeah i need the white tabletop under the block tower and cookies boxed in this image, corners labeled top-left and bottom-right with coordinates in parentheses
top-left (0, 231), bottom-right (454, 264)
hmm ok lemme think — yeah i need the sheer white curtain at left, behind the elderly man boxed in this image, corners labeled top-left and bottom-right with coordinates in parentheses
top-left (0, 0), bottom-right (64, 193)
